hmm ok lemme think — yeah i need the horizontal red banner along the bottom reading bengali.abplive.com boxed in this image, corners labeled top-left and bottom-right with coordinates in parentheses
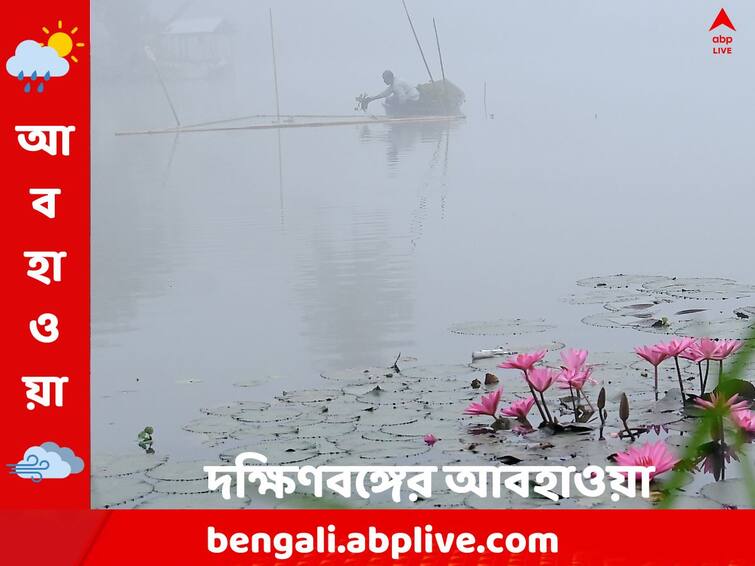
top-left (3, 510), bottom-right (752, 566)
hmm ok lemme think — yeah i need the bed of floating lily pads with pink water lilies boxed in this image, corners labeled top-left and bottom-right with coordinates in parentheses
top-left (93, 275), bottom-right (755, 509)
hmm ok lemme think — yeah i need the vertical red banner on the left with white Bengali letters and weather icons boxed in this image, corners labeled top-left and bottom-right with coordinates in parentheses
top-left (0, 0), bottom-right (90, 509)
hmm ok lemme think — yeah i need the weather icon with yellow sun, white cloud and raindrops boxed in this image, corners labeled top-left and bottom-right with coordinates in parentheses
top-left (5, 20), bottom-right (84, 93)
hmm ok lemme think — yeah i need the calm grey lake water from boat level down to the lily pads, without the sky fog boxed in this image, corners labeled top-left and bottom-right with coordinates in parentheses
top-left (92, 72), bottom-right (755, 462)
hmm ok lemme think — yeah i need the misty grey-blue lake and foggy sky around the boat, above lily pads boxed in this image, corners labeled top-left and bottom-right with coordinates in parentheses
top-left (92, 0), bottom-right (755, 470)
